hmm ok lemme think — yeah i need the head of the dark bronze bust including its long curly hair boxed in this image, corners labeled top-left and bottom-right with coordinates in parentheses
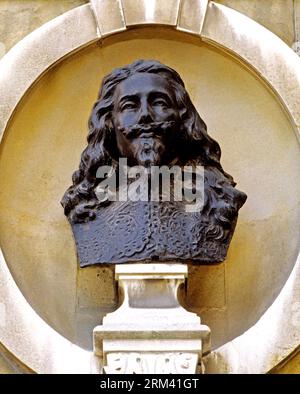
top-left (62, 60), bottom-right (235, 222)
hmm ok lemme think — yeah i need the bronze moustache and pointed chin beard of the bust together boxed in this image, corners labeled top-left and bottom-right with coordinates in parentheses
top-left (119, 121), bottom-right (175, 167)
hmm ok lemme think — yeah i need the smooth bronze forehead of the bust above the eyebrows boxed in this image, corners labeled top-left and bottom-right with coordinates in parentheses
top-left (115, 73), bottom-right (173, 99)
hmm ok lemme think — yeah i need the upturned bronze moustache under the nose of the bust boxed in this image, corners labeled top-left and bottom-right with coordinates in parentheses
top-left (118, 120), bottom-right (175, 139)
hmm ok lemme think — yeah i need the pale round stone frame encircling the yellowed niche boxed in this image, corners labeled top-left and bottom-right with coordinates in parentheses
top-left (0, 0), bottom-right (300, 373)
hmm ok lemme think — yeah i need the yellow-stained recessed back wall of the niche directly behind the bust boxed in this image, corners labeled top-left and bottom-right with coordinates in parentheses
top-left (0, 28), bottom-right (300, 349)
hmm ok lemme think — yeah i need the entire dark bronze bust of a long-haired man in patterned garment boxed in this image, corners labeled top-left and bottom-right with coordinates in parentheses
top-left (62, 60), bottom-right (247, 267)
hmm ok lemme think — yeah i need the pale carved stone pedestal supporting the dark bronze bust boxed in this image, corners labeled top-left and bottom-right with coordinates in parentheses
top-left (94, 264), bottom-right (210, 374)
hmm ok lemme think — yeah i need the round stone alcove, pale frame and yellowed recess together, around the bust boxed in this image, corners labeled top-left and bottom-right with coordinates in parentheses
top-left (0, 0), bottom-right (300, 373)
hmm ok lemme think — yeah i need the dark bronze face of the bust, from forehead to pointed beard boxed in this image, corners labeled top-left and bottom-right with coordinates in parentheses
top-left (112, 73), bottom-right (179, 167)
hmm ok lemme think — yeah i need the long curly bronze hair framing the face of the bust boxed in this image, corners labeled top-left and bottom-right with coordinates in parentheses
top-left (61, 60), bottom-right (235, 223)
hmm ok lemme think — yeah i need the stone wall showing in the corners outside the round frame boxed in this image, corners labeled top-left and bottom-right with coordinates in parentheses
top-left (0, 0), bottom-right (300, 373)
